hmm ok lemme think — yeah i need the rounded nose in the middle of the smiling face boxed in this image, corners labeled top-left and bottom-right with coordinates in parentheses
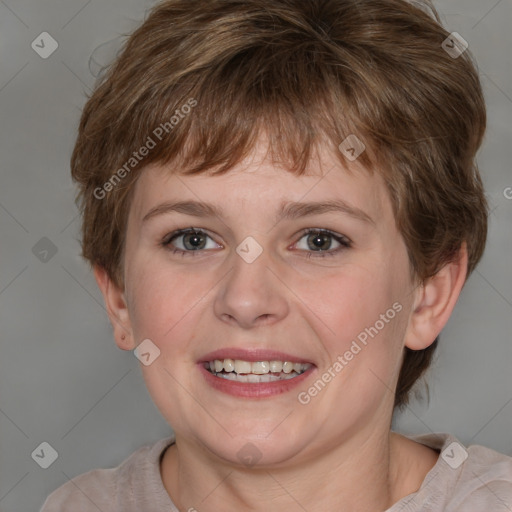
top-left (214, 247), bottom-right (289, 329)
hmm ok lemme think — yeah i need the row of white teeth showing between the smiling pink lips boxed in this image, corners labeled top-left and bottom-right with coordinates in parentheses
top-left (204, 358), bottom-right (312, 384)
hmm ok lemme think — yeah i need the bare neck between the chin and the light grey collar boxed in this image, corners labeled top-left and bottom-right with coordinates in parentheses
top-left (161, 431), bottom-right (422, 512)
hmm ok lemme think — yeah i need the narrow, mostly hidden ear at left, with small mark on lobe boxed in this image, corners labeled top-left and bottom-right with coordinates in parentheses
top-left (93, 265), bottom-right (135, 350)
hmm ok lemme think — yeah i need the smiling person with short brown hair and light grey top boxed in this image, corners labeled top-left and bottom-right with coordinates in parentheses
top-left (42, 0), bottom-right (512, 512)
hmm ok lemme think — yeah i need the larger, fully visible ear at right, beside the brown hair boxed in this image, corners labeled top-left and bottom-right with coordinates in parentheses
top-left (405, 243), bottom-right (468, 350)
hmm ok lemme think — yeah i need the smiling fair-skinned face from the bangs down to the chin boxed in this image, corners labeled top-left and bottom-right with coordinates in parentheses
top-left (119, 140), bottom-right (413, 465)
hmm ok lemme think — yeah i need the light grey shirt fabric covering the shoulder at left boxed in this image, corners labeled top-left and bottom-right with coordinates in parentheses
top-left (40, 438), bottom-right (173, 512)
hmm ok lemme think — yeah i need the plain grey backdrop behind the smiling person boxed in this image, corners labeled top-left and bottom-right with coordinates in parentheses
top-left (0, 0), bottom-right (512, 512)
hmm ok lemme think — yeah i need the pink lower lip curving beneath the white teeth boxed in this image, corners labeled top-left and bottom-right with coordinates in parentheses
top-left (197, 362), bottom-right (316, 399)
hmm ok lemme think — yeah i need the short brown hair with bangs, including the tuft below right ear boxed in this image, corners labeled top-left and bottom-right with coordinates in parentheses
top-left (71, 0), bottom-right (488, 406)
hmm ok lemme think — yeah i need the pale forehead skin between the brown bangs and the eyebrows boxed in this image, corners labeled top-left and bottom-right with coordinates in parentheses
top-left (130, 144), bottom-right (392, 226)
